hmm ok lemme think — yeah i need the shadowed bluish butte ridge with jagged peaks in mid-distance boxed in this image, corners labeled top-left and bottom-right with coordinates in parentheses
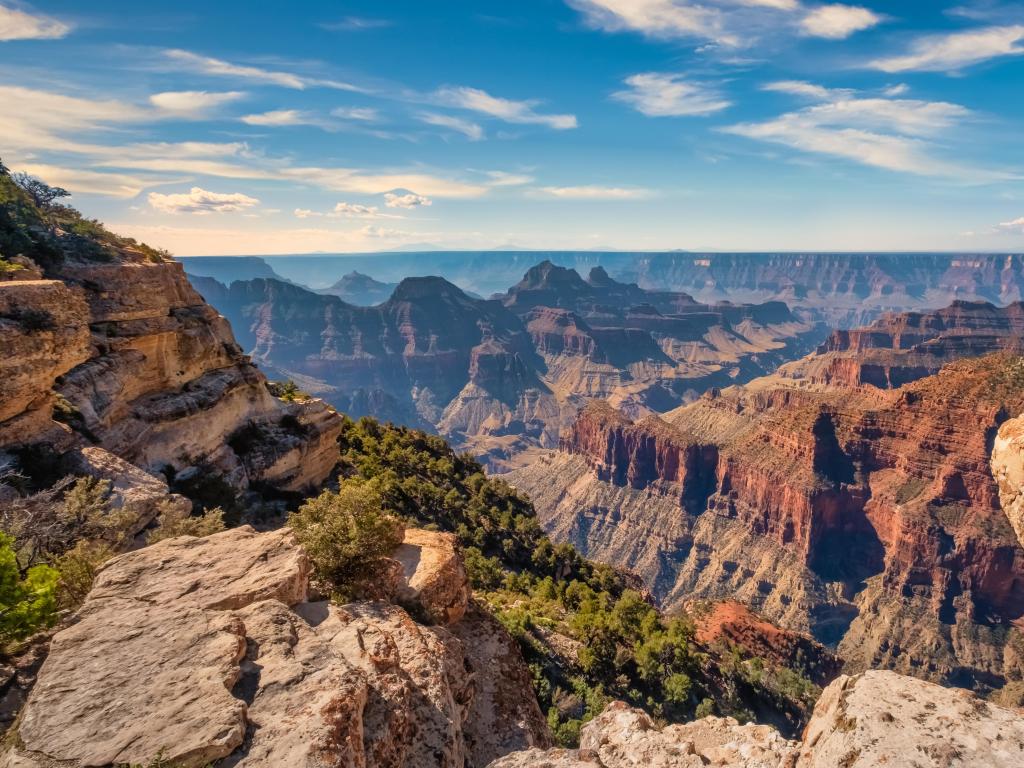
top-left (200, 262), bottom-right (822, 467)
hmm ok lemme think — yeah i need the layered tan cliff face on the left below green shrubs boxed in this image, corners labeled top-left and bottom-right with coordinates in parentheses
top-left (0, 251), bottom-right (340, 490)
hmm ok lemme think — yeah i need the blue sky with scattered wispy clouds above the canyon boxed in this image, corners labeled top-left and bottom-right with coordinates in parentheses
top-left (0, 0), bottom-right (1024, 255)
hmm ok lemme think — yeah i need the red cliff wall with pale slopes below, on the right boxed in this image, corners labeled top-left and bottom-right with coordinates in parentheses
top-left (509, 356), bottom-right (1024, 690)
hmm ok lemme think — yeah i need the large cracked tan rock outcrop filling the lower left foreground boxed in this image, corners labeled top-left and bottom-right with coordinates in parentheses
top-left (2, 527), bottom-right (550, 768)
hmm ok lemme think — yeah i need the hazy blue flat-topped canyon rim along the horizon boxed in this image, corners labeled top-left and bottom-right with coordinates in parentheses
top-left (186, 251), bottom-right (1024, 328)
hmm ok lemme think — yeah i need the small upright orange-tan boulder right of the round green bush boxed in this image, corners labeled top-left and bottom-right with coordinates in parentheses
top-left (391, 528), bottom-right (469, 625)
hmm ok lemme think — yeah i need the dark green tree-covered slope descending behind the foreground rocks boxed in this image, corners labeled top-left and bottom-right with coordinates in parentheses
top-left (323, 419), bottom-right (818, 744)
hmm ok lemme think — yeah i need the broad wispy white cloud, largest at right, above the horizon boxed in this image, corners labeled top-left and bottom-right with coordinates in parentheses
top-left (724, 87), bottom-right (1009, 181)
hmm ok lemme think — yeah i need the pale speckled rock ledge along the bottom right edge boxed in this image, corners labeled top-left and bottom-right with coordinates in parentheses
top-left (490, 672), bottom-right (1024, 768)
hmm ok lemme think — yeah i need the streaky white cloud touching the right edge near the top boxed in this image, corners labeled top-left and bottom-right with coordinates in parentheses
top-left (868, 25), bottom-right (1024, 73)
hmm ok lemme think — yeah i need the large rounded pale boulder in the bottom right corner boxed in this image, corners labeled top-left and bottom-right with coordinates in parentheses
top-left (798, 670), bottom-right (1024, 768)
